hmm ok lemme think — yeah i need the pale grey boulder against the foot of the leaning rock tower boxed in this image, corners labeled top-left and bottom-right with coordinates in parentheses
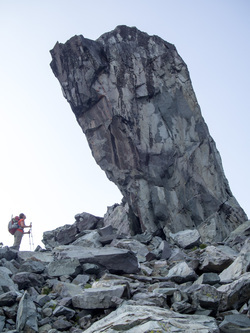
top-left (169, 230), bottom-right (200, 249)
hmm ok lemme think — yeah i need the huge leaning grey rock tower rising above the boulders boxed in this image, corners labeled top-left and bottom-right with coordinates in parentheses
top-left (51, 26), bottom-right (247, 241)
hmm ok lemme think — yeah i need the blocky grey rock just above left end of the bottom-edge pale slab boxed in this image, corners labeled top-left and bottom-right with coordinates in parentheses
top-left (72, 285), bottom-right (125, 309)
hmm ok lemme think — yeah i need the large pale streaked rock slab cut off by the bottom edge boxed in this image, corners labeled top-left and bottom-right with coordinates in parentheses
top-left (81, 304), bottom-right (219, 333)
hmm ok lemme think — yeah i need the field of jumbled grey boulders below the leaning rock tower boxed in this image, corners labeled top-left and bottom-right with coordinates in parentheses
top-left (0, 213), bottom-right (250, 333)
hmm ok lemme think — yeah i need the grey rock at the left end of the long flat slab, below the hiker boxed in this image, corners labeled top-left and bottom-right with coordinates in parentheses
top-left (47, 258), bottom-right (81, 277)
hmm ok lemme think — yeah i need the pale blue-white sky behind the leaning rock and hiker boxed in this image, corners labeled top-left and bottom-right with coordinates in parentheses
top-left (0, 0), bottom-right (250, 250)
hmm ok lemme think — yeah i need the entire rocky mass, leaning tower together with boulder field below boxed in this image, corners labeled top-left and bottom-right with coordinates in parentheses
top-left (0, 26), bottom-right (250, 333)
